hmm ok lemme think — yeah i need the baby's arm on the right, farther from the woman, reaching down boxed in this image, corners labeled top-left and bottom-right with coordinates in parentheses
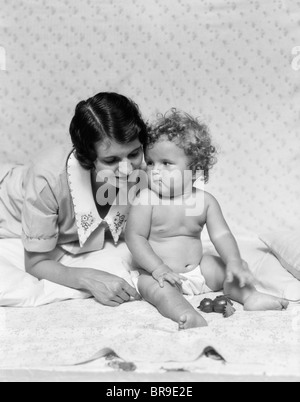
top-left (205, 193), bottom-right (254, 287)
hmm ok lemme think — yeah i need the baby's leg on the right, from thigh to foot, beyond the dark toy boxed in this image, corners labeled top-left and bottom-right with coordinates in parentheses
top-left (201, 255), bottom-right (289, 311)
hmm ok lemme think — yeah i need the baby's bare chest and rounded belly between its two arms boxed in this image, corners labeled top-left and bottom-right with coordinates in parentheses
top-left (148, 205), bottom-right (203, 273)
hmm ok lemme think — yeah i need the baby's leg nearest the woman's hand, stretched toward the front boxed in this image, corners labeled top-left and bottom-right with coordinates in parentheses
top-left (138, 274), bottom-right (207, 330)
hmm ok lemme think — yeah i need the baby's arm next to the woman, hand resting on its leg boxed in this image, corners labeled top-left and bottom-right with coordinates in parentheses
top-left (125, 190), bottom-right (182, 287)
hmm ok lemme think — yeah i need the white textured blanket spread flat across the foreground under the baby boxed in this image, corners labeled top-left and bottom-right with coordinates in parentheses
top-left (0, 294), bottom-right (300, 379)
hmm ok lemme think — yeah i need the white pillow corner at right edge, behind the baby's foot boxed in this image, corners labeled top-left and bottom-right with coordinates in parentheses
top-left (260, 231), bottom-right (300, 280)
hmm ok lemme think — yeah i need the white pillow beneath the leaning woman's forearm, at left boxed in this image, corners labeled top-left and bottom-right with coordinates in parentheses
top-left (0, 239), bottom-right (133, 307)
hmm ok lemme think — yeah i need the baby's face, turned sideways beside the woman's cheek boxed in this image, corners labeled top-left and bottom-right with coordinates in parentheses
top-left (145, 139), bottom-right (193, 198)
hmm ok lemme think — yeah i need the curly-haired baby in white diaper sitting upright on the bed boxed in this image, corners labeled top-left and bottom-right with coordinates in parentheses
top-left (126, 109), bottom-right (288, 330)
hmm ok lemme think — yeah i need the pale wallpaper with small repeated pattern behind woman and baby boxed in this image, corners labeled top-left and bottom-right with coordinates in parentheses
top-left (0, 0), bottom-right (300, 232)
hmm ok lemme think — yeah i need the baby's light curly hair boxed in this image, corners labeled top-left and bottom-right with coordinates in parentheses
top-left (145, 108), bottom-right (217, 183)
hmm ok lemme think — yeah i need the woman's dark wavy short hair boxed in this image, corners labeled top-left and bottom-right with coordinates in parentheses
top-left (70, 92), bottom-right (147, 169)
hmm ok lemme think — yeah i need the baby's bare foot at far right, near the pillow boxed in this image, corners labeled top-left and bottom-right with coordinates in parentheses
top-left (244, 292), bottom-right (289, 311)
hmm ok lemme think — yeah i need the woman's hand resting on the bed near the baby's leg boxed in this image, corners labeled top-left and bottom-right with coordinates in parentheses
top-left (82, 269), bottom-right (141, 307)
